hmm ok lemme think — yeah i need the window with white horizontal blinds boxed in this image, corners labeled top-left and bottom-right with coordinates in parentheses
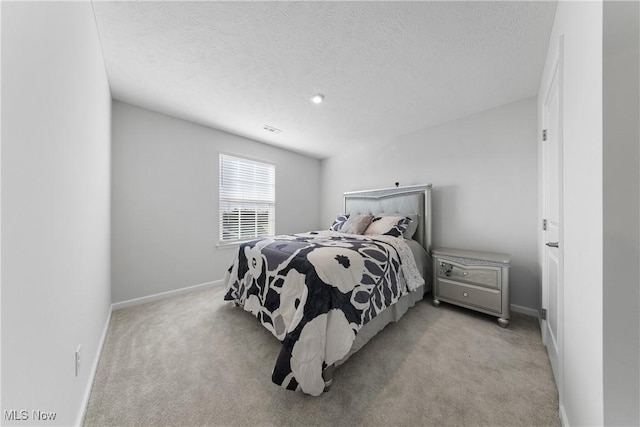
top-left (220, 154), bottom-right (276, 243)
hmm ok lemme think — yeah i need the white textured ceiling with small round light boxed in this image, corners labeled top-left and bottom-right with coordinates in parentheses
top-left (93, 1), bottom-right (556, 158)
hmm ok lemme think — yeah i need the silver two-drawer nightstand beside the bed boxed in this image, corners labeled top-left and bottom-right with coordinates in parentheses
top-left (432, 248), bottom-right (511, 328)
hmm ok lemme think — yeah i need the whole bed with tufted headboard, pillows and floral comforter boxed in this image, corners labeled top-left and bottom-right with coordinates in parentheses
top-left (225, 184), bottom-right (432, 396)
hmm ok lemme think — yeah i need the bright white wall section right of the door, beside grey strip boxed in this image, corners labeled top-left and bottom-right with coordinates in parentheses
top-left (540, 2), bottom-right (604, 425)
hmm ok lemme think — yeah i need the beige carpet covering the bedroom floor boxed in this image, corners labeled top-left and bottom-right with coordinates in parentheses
top-left (84, 288), bottom-right (560, 426)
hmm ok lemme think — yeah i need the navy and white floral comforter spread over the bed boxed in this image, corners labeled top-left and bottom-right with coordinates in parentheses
top-left (225, 231), bottom-right (424, 396)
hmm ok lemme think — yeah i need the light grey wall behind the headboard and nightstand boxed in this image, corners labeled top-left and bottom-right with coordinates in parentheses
top-left (321, 98), bottom-right (540, 310)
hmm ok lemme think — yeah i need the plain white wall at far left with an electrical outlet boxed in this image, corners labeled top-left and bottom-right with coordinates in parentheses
top-left (1, 2), bottom-right (111, 425)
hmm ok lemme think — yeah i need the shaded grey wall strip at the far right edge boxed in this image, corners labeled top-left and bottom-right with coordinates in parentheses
top-left (603, 1), bottom-right (640, 426)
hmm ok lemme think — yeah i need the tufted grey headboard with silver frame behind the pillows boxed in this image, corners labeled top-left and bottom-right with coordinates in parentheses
top-left (344, 184), bottom-right (431, 254)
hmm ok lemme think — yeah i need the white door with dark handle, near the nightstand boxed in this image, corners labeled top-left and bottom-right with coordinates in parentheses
top-left (541, 41), bottom-right (563, 389)
